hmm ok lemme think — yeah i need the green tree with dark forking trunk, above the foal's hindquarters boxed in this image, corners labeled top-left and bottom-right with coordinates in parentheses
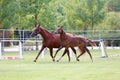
top-left (74, 0), bottom-right (106, 29)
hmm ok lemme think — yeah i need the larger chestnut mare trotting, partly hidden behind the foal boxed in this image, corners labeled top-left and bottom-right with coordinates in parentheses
top-left (31, 25), bottom-right (79, 62)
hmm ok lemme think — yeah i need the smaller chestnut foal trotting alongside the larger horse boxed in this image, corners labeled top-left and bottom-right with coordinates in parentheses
top-left (54, 26), bottom-right (96, 62)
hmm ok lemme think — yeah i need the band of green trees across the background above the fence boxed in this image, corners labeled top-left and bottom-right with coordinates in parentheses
top-left (0, 0), bottom-right (120, 30)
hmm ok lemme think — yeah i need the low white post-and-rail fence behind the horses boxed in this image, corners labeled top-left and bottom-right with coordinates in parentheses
top-left (0, 39), bottom-right (108, 59)
